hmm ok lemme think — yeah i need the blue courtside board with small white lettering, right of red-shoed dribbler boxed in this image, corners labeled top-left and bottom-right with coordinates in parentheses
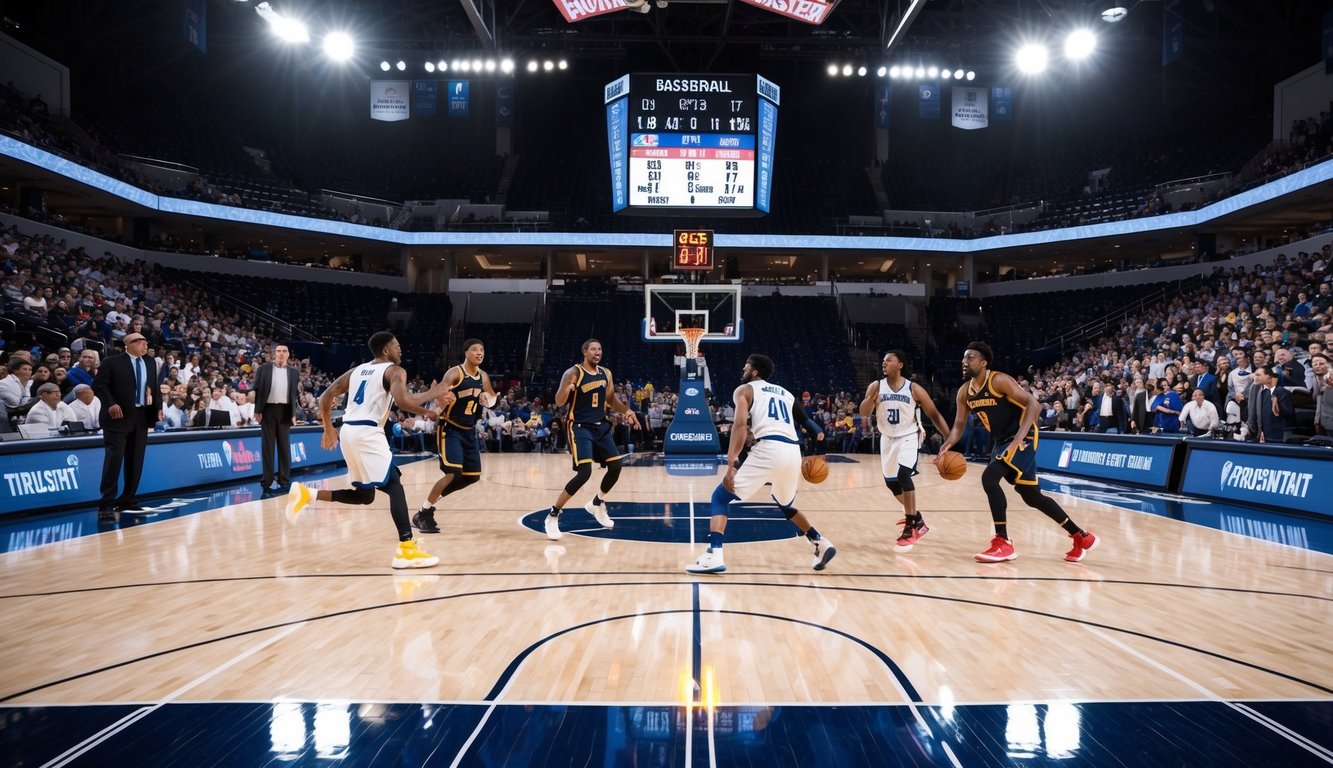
top-left (1037, 432), bottom-right (1181, 491)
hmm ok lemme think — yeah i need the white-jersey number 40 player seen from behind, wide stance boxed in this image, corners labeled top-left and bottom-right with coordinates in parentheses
top-left (685, 355), bottom-right (837, 573)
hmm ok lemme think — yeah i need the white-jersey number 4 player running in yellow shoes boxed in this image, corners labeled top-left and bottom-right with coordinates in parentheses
top-left (287, 331), bottom-right (455, 568)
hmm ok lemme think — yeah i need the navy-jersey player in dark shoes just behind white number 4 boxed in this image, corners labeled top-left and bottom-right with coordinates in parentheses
top-left (412, 339), bottom-right (496, 533)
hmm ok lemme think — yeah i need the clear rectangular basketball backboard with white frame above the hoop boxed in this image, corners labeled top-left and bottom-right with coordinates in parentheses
top-left (643, 285), bottom-right (745, 344)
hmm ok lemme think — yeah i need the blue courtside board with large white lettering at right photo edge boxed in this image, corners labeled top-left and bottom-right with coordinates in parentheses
top-left (1180, 440), bottom-right (1333, 516)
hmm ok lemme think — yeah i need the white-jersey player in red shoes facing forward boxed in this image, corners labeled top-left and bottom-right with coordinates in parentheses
top-left (861, 349), bottom-right (949, 552)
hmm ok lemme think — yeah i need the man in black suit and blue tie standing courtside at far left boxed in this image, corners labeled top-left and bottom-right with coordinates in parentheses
top-left (92, 333), bottom-right (161, 519)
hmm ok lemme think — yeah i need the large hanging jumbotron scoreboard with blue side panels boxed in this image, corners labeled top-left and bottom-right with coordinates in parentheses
top-left (604, 75), bottom-right (781, 216)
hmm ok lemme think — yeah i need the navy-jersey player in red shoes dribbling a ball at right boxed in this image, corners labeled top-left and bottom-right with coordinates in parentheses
top-left (940, 341), bottom-right (1097, 563)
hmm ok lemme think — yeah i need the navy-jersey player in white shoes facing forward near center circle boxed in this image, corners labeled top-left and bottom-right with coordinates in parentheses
top-left (545, 339), bottom-right (639, 541)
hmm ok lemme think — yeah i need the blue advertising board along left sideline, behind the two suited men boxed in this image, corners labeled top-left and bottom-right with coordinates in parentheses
top-left (0, 427), bottom-right (343, 512)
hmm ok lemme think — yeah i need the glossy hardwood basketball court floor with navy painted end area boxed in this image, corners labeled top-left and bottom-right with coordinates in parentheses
top-left (0, 455), bottom-right (1333, 765)
